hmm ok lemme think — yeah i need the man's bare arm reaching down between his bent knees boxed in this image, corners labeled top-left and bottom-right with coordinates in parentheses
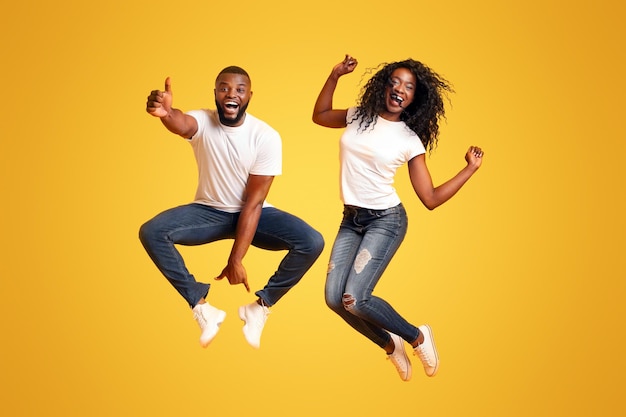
top-left (215, 175), bottom-right (274, 292)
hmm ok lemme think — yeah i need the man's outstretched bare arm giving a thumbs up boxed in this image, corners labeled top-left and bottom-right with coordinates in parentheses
top-left (146, 77), bottom-right (198, 139)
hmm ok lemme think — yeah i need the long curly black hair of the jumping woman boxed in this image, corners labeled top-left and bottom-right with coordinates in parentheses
top-left (352, 58), bottom-right (454, 151)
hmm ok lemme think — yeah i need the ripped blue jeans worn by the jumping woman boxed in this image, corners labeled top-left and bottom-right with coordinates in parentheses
top-left (325, 204), bottom-right (419, 348)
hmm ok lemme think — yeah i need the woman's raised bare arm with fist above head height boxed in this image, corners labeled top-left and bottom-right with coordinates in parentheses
top-left (313, 55), bottom-right (358, 128)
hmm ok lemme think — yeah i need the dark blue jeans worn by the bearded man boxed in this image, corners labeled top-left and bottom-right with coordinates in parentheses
top-left (139, 203), bottom-right (324, 308)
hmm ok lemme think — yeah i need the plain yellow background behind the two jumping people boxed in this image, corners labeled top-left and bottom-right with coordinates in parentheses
top-left (0, 0), bottom-right (626, 417)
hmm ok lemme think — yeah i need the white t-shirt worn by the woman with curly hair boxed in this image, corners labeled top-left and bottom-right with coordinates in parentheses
top-left (339, 107), bottom-right (426, 210)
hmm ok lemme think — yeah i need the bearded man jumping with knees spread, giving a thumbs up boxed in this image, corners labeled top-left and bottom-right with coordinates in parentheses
top-left (139, 66), bottom-right (324, 348)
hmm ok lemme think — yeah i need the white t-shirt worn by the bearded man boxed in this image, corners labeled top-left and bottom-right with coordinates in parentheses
top-left (187, 109), bottom-right (282, 213)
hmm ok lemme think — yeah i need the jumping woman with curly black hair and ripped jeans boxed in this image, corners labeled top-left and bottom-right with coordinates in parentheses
top-left (313, 55), bottom-right (483, 381)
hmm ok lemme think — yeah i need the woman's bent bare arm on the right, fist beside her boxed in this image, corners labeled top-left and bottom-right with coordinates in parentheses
top-left (408, 146), bottom-right (484, 210)
